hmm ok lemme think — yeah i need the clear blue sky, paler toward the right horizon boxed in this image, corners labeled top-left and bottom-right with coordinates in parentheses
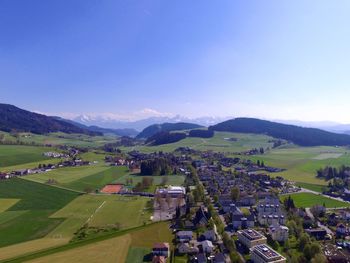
top-left (0, 0), bottom-right (350, 122)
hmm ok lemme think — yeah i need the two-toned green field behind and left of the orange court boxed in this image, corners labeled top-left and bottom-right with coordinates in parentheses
top-left (24, 166), bottom-right (128, 192)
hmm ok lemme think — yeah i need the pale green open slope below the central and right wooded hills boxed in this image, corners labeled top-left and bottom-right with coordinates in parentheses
top-left (121, 132), bottom-right (272, 152)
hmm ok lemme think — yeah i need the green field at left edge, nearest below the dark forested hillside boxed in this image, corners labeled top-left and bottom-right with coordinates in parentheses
top-left (0, 145), bottom-right (50, 171)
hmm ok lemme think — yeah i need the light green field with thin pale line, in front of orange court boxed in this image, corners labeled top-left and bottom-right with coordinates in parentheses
top-left (47, 195), bottom-right (152, 238)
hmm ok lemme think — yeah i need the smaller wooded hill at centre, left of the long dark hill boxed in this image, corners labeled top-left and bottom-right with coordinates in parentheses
top-left (137, 122), bottom-right (203, 139)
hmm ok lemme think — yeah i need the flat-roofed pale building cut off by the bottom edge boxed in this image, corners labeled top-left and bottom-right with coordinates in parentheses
top-left (251, 244), bottom-right (287, 263)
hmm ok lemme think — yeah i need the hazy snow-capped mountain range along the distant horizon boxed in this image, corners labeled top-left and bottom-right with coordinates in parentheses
top-left (72, 115), bottom-right (232, 131)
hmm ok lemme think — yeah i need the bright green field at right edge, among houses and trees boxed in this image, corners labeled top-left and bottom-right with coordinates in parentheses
top-left (281, 193), bottom-right (350, 208)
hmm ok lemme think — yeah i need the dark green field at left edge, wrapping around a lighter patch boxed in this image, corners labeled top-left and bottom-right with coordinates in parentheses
top-left (0, 178), bottom-right (77, 247)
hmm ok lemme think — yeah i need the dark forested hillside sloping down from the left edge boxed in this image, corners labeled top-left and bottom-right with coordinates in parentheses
top-left (0, 103), bottom-right (101, 135)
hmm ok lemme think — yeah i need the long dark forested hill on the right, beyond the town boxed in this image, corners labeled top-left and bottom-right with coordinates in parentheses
top-left (209, 118), bottom-right (350, 146)
